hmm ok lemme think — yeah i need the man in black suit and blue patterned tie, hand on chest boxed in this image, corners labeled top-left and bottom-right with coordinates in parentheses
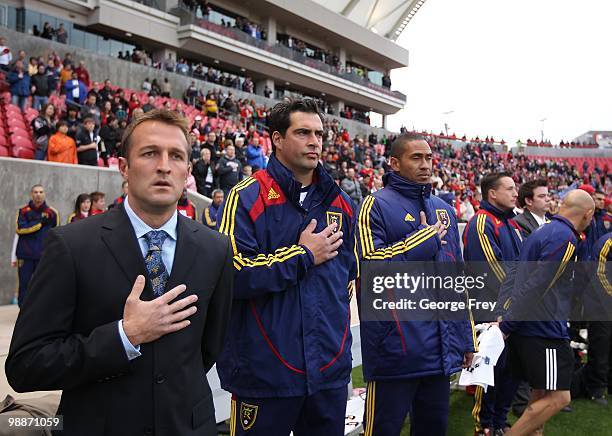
top-left (6, 110), bottom-right (233, 436)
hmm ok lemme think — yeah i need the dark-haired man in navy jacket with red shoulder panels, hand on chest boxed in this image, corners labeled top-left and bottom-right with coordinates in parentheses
top-left (217, 99), bottom-right (356, 436)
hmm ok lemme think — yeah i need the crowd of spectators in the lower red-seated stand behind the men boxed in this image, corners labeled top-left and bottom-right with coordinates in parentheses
top-left (0, 40), bottom-right (612, 221)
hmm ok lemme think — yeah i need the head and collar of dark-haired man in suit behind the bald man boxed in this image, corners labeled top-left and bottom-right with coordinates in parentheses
top-left (514, 179), bottom-right (550, 237)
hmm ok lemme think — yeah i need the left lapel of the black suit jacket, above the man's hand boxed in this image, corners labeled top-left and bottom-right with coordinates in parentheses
top-left (102, 204), bottom-right (153, 300)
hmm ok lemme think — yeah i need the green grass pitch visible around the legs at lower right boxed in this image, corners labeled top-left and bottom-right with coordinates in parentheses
top-left (353, 367), bottom-right (612, 436)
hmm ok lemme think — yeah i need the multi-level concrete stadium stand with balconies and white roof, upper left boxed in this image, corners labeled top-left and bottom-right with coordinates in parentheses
top-left (0, 0), bottom-right (416, 126)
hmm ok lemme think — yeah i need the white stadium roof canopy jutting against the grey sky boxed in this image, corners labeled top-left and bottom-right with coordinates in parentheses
top-left (313, 0), bottom-right (426, 41)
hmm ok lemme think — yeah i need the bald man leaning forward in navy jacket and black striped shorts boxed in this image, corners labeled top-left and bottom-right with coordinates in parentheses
top-left (499, 190), bottom-right (595, 435)
